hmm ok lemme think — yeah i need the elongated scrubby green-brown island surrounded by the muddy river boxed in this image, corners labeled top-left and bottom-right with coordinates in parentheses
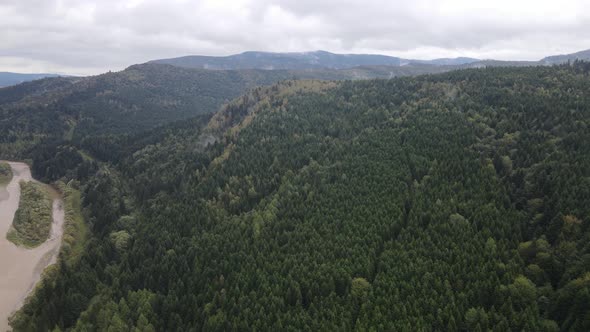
top-left (6, 181), bottom-right (52, 248)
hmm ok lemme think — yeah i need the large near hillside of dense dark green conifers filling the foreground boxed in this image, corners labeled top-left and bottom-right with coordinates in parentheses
top-left (5, 62), bottom-right (590, 331)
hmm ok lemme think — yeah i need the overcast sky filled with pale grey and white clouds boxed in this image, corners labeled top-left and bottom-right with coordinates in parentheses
top-left (0, 0), bottom-right (590, 75)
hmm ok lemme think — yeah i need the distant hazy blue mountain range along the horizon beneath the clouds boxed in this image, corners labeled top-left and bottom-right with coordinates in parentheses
top-left (0, 50), bottom-right (590, 88)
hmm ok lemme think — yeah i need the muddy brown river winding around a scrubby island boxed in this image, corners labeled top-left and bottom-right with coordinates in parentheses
top-left (0, 162), bottom-right (64, 331)
